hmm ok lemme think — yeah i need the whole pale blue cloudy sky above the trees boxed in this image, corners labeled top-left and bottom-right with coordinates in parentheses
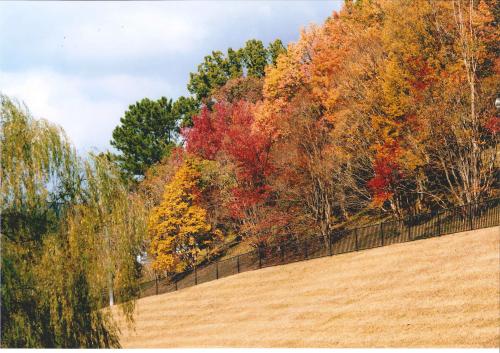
top-left (0, 0), bottom-right (343, 152)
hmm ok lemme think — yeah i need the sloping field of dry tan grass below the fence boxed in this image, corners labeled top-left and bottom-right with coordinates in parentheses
top-left (114, 227), bottom-right (500, 348)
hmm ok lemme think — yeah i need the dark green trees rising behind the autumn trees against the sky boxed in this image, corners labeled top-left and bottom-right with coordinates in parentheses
top-left (111, 39), bottom-right (285, 177)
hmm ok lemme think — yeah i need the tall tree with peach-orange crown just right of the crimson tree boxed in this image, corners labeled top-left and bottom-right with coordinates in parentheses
top-left (255, 21), bottom-right (374, 238)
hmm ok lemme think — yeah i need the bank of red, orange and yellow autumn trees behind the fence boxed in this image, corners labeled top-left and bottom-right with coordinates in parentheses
top-left (124, 0), bottom-right (500, 274)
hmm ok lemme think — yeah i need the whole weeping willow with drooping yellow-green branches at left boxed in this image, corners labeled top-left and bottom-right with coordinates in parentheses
top-left (0, 96), bottom-right (145, 347)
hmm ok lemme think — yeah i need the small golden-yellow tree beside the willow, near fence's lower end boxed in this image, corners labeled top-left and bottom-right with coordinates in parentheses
top-left (149, 159), bottom-right (222, 273)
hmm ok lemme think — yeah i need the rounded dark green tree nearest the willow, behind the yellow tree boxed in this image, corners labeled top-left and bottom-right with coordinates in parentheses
top-left (111, 97), bottom-right (180, 176)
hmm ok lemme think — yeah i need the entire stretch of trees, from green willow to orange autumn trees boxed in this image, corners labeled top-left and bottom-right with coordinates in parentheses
top-left (1, 0), bottom-right (500, 347)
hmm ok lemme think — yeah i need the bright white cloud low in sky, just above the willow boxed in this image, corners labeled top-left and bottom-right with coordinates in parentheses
top-left (0, 71), bottom-right (171, 152)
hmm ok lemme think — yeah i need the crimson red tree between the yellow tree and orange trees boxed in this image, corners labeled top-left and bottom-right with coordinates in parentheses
top-left (184, 101), bottom-right (272, 242)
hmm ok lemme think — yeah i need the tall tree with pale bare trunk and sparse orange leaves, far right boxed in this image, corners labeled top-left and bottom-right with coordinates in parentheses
top-left (422, 0), bottom-right (500, 205)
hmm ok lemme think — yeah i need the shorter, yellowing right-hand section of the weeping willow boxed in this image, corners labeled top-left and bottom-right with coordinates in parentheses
top-left (74, 154), bottom-right (146, 309)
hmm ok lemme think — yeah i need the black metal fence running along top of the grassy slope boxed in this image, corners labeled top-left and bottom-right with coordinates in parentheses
top-left (128, 198), bottom-right (500, 298)
